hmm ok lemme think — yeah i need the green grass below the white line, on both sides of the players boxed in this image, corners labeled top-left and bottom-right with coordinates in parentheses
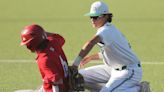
top-left (0, 61), bottom-right (164, 92)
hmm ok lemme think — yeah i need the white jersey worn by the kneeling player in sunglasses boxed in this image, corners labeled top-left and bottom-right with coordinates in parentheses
top-left (96, 23), bottom-right (140, 68)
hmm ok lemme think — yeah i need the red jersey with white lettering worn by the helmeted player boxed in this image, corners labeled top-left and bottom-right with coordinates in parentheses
top-left (36, 34), bottom-right (69, 92)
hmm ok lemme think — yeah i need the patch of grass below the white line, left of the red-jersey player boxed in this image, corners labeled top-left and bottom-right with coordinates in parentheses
top-left (0, 62), bottom-right (41, 92)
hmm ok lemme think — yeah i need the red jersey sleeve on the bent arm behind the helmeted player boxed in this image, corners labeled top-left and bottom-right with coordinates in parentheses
top-left (48, 34), bottom-right (65, 46)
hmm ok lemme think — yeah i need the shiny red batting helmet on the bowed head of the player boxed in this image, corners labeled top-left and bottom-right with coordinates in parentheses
top-left (21, 24), bottom-right (47, 51)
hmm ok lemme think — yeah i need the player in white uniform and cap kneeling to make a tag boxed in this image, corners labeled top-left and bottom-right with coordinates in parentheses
top-left (73, 1), bottom-right (151, 92)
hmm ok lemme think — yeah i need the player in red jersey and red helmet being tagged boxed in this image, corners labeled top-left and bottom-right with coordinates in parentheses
top-left (21, 24), bottom-right (69, 92)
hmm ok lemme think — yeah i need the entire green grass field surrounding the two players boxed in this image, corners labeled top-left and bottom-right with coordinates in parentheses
top-left (0, 0), bottom-right (164, 92)
